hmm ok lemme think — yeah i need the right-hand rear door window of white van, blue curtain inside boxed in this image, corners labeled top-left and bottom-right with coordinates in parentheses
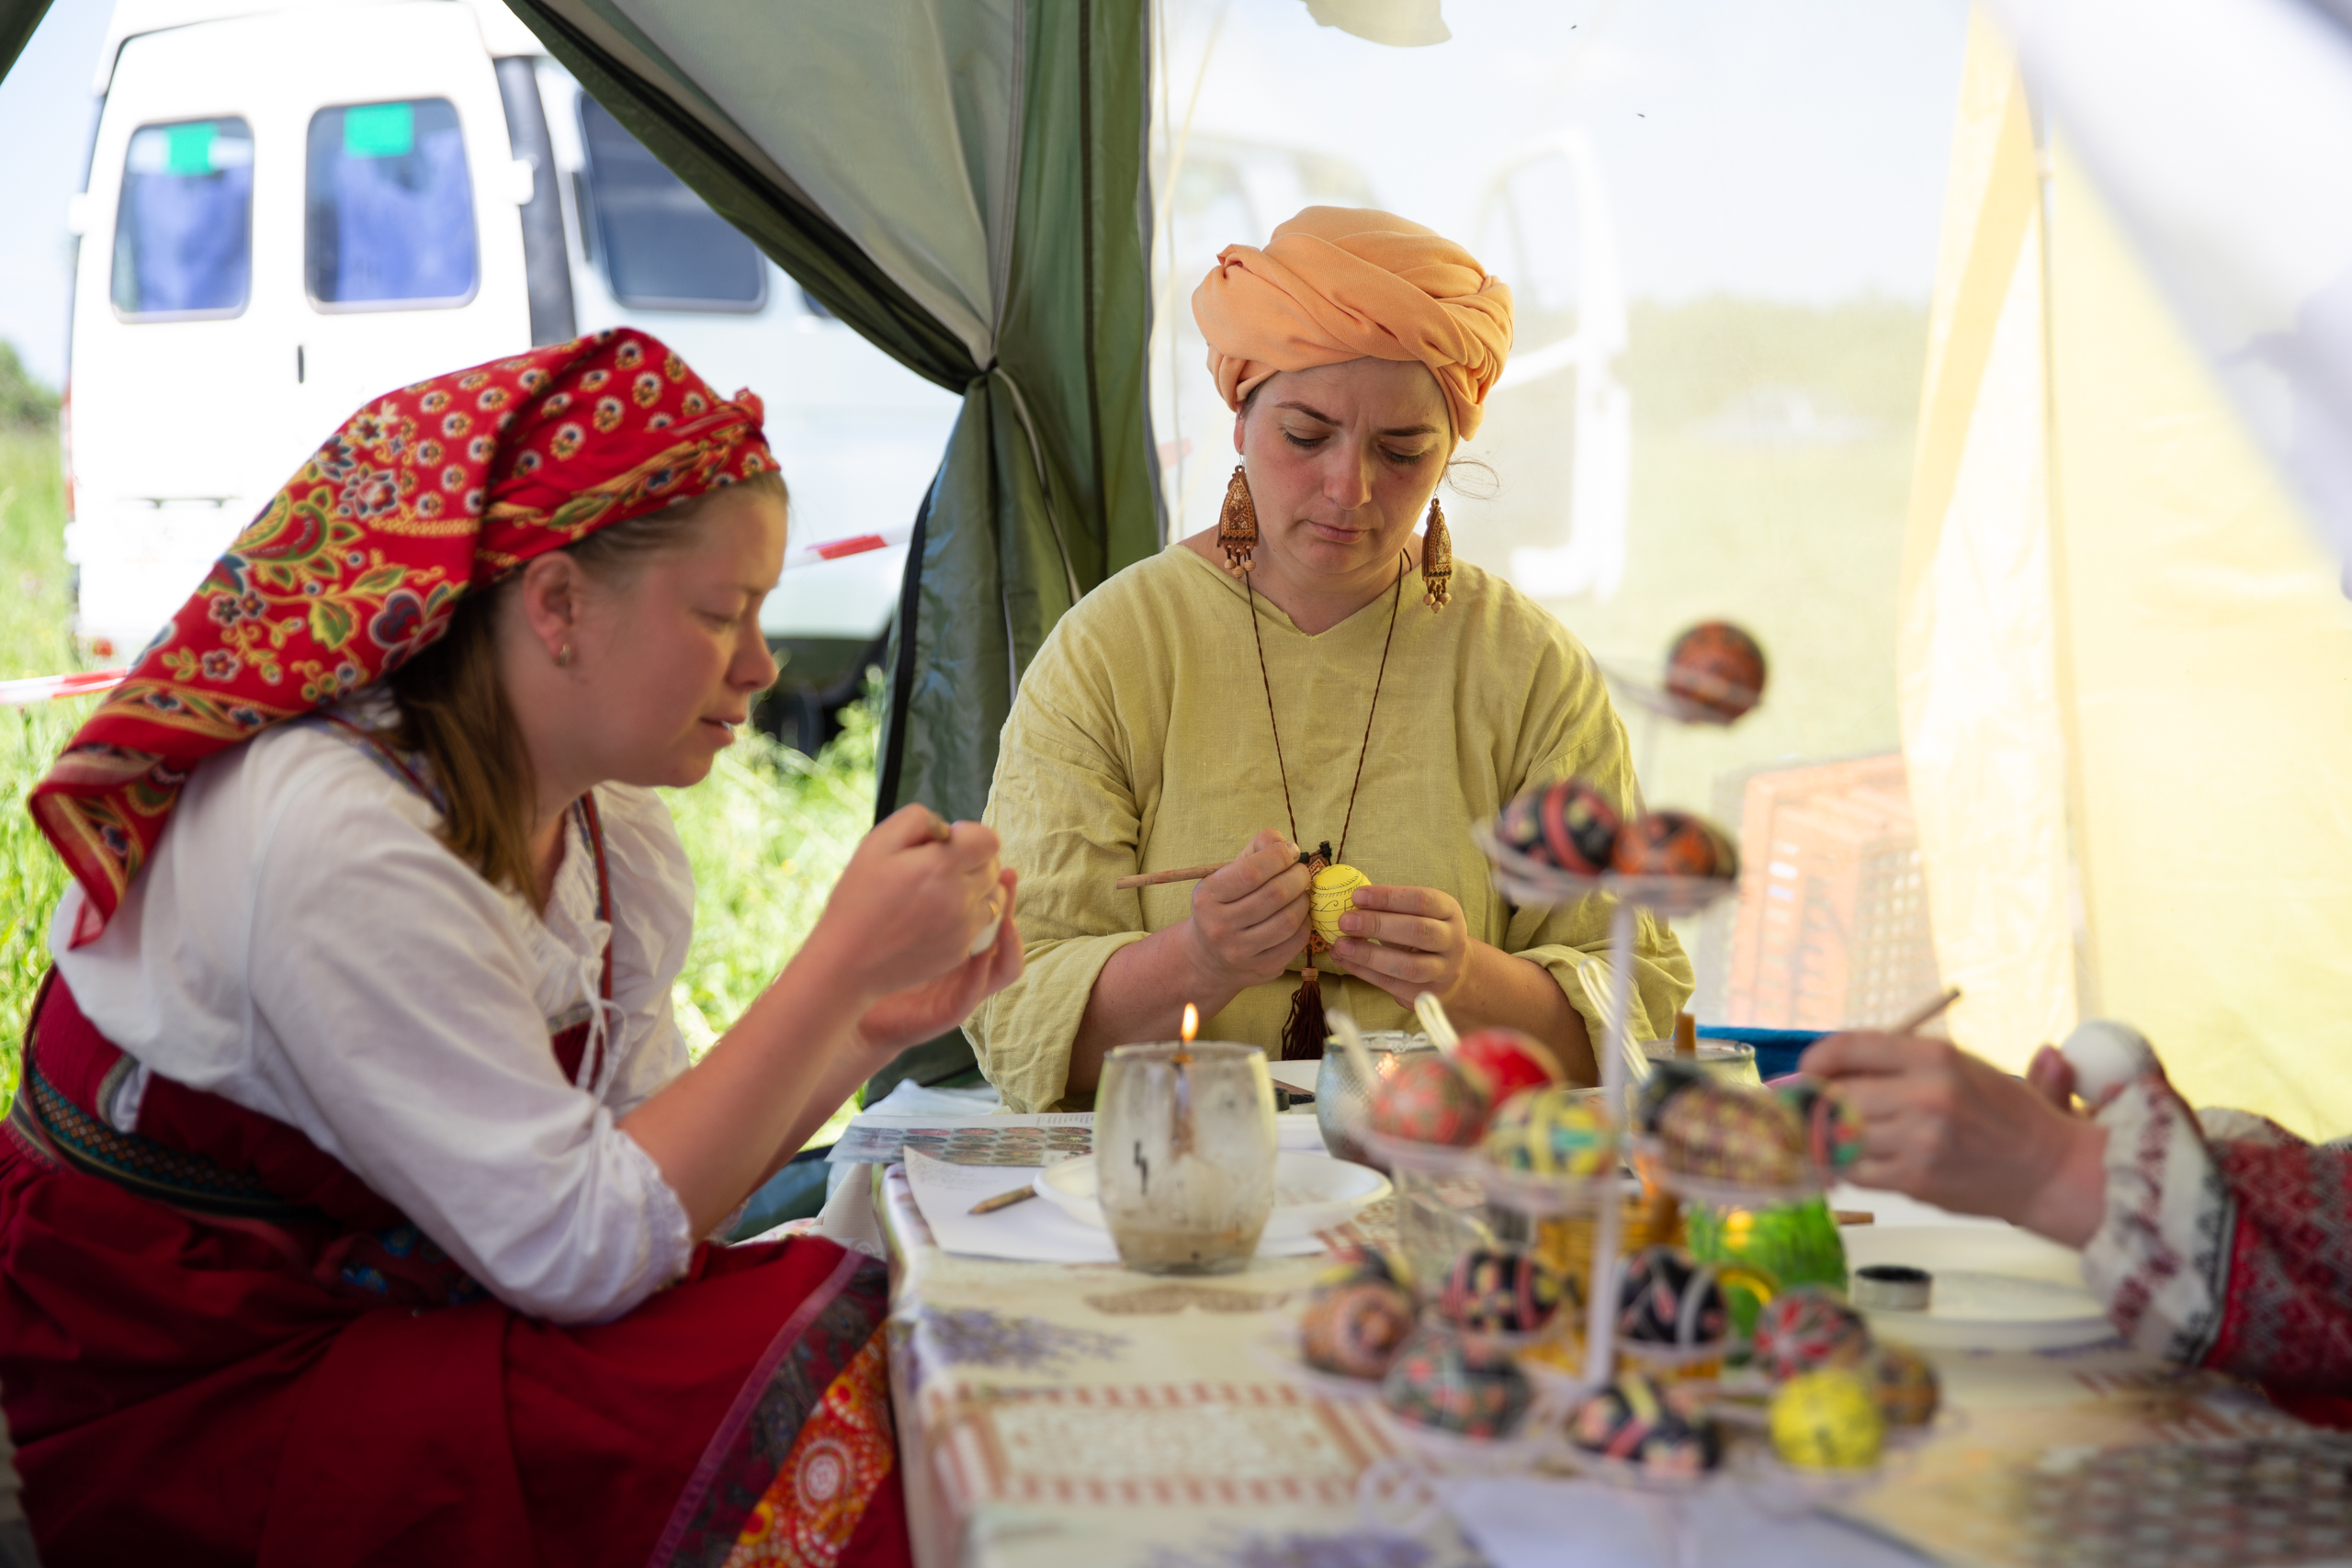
top-left (303, 98), bottom-right (480, 310)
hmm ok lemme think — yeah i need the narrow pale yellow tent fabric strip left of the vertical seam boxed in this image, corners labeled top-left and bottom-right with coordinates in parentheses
top-left (1895, 14), bottom-right (2076, 1065)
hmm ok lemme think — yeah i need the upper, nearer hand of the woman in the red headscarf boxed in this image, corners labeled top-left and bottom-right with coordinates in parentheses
top-left (802, 807), bottom-right (1012, 1010)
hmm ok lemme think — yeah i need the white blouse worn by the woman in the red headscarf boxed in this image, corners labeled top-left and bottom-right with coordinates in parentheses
top-left (50, 710), bottom-right (694, 1321)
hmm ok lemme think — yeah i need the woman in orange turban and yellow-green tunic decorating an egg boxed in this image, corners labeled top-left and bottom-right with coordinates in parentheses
top-left (965, 207), bottom-right (1691, 1110)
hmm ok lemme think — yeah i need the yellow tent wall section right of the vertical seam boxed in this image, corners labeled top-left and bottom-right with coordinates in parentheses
top-left (2051, 150), bottom-right (2352, 1138)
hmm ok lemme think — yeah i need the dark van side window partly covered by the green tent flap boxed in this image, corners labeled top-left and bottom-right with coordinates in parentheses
top-left (581, 94), bottom-right (767, 310)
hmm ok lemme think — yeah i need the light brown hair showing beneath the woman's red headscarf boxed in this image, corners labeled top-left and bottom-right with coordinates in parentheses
top-left (386, 470), bottom-right (788, 905)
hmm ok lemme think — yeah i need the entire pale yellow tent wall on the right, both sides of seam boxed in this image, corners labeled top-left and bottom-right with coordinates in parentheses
top-left (1898, 0), bottom-right (2352, 1135)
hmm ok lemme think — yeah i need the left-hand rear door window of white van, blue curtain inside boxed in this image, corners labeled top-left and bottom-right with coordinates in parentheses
top-left (113, 120), bottom-right (254, 320)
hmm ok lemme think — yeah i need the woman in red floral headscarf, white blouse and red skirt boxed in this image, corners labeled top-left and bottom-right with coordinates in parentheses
top-left (0, 332), bottom-right (1021, 1568)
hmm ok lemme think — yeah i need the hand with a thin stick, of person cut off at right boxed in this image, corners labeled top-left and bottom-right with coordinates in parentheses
top-left (1799, 1034), bottom-right (2108, 1246)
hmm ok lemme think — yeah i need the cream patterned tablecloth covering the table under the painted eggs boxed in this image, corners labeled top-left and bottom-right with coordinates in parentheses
top-left (875, 1166), bottom-right (2293, 1568)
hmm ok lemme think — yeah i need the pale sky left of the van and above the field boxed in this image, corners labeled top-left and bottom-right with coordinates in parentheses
top-left (0, 0), bottom-right (1966, 383)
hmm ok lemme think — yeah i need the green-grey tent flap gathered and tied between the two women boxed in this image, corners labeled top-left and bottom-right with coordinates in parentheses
top-left (513, 0), bottom-right (1159, 1077)
